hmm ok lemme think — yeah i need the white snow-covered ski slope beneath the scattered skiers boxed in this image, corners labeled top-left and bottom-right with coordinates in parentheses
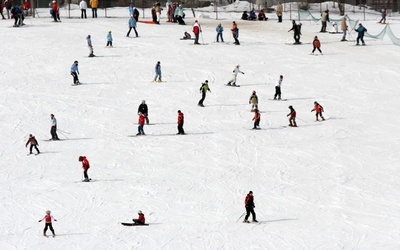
top-left (0, 2), bottom-right (400, 249)
